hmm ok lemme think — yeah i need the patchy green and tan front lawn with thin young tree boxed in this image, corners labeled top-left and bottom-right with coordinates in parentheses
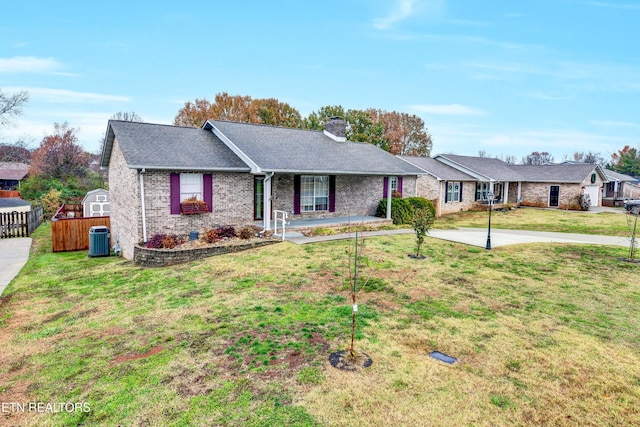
top-left (0, 219), bottom-right (640, 426)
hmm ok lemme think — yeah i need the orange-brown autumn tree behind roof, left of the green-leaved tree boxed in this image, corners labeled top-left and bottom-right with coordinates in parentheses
top-left (173, 92), bottom-right (302, 127)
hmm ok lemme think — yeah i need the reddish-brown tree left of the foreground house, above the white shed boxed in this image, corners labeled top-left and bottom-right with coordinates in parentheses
top-left (29, 122), bottom-right (89, 182)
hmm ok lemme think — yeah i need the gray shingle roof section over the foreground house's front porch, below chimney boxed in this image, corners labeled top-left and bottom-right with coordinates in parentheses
top-left (205, 120), bottom-right (422, 175)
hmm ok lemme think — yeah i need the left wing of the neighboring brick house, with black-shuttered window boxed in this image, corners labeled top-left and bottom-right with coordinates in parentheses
top-left (399, 156), bottom-right (478, 217)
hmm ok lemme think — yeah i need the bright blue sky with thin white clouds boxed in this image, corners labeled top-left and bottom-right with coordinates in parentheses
top-left (0, 0), bottom-right (640, 160)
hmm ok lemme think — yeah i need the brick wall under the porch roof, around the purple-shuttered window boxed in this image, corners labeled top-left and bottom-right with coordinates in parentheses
top-left (273, 174), bottom-right (416, 219)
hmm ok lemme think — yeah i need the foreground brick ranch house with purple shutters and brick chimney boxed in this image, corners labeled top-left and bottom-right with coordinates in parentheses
top-left (101, 119), bottom-right (422, 259)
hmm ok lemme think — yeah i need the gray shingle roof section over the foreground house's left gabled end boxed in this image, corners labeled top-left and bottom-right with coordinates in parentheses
top-left (101, 120), bottom-right (249, 171)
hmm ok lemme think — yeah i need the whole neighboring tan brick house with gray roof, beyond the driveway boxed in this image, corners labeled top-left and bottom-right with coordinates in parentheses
top-left (401, 154), bottom-right (609, 215)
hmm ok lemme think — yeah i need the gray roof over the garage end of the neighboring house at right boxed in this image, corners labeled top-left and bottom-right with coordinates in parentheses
top-left (511, 163), bottom-right (608, 183)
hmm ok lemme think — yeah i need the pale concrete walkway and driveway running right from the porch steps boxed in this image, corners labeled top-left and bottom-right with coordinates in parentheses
top-left (287, 228), bottom-right (630, 248)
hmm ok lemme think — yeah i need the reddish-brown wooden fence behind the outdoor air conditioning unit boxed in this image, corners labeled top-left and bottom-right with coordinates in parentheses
top-left (51, 216), bottom-right (111, 252)
